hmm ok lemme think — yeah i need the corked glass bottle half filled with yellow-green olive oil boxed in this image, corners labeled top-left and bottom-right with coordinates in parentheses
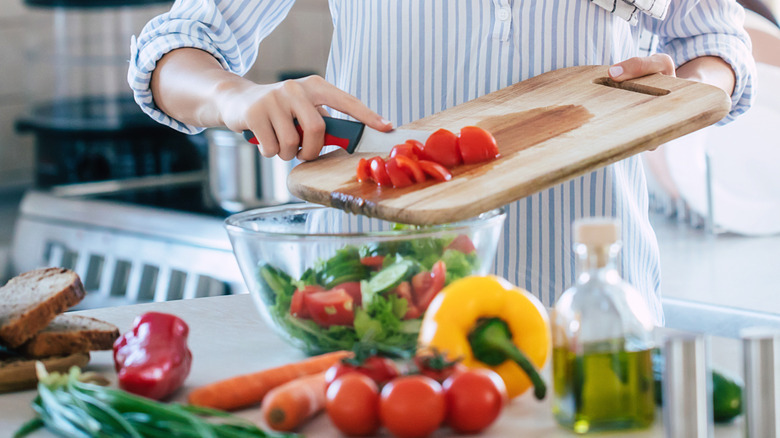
top-left (552, 218), bottom-right (655, 434)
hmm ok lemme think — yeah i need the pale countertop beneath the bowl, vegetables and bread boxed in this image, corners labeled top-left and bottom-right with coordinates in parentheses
top-left (0, 295), bottom-right (743, 438)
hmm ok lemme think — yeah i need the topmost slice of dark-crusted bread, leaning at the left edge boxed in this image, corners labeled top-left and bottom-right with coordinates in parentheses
top-left (0, 268), bottom-right (85, 348)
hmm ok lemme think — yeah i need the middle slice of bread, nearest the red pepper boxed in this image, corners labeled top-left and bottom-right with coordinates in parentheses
top-left (16, 313), bottom-right (119, 357)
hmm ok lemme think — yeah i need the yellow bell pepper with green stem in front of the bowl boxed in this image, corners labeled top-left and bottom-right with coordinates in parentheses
top-left (419, 276), bottom-right (550, 400)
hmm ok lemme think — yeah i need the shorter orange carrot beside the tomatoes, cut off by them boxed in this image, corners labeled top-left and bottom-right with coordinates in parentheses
top-left (261, 373), bottom-right (326, 432)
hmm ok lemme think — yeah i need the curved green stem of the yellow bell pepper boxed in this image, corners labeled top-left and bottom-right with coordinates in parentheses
top-left (469, 318), bottom-right (547, 400)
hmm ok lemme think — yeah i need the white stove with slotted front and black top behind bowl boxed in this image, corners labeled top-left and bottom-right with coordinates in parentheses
top-left (11, 183), bottom-right (262, 308)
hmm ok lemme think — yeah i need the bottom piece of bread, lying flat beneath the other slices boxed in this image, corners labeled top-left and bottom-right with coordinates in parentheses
top-left (0, 353), bottom-right (89, 393)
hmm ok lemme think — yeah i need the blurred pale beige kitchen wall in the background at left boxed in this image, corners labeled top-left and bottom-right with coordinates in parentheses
top-left (0, 0), bottom-right (332, 189)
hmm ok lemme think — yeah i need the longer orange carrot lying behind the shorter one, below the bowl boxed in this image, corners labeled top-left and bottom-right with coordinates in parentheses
top-left (188, 351), bottom-right (352, 411)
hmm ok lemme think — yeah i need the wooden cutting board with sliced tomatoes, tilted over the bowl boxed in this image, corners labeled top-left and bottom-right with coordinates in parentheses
top-left (287, 66), bottom-right (731, 225)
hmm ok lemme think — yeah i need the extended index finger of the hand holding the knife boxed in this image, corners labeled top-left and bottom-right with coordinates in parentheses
top-left (299, 76), bottom-right (393, 131)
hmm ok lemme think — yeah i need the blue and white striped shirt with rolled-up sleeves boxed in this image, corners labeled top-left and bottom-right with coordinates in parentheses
top-left (128, 0), bottom-right (754, 323)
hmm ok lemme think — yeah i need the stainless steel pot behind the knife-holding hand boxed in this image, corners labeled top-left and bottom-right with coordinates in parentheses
top-left (206, 128), bottom-right (298, 213)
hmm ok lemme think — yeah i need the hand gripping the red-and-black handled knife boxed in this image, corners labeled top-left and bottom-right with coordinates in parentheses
top-left (218, 76), bottom-right (392, 160)
